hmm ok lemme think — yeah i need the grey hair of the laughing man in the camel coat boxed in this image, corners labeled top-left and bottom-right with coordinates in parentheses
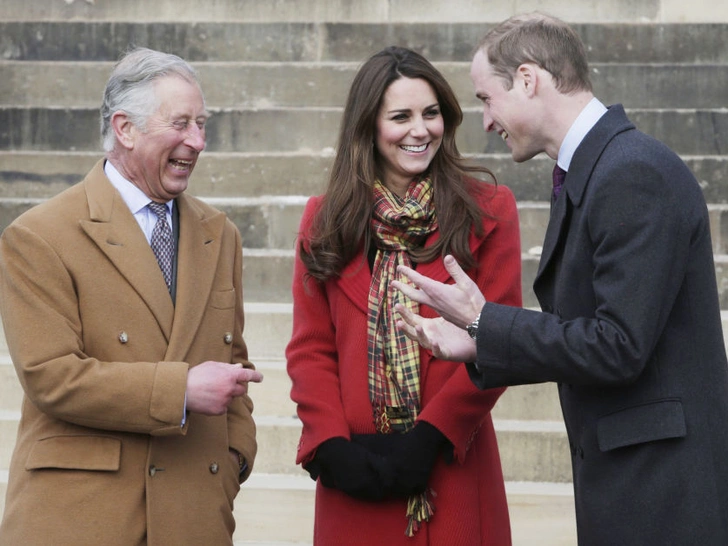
top-left (101, 47), bottom-right (200, 152)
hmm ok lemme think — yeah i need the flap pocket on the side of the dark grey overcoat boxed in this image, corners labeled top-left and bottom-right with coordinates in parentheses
top-left (597, 399), bottom-right (687, 451)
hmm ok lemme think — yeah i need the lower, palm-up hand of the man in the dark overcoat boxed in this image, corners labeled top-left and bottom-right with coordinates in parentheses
top-left (394, 304), bottom-right (477, 362)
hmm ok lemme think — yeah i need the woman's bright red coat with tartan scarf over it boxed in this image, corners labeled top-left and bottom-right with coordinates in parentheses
top-left (286, 186), bottom-right (521, 546)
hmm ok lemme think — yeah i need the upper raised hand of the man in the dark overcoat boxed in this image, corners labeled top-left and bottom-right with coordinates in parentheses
top-left (390, 255), bottom-right (485, 326)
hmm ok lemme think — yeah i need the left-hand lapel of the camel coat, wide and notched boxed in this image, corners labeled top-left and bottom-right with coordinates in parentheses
top-left (79, 160), bottom-right (174, 339)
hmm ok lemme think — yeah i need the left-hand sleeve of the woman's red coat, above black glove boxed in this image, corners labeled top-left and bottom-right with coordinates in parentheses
top-left (286, 198), bottom-right (349, 464)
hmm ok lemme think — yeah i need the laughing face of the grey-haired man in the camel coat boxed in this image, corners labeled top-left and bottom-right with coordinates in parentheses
top-left (124, 76), bottom-right (209, 202)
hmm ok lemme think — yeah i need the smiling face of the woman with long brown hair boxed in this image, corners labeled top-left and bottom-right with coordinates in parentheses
top-left (375, 77), bottom-right (445, 196)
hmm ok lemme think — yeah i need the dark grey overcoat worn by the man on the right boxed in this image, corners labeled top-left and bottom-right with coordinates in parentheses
top-left (469, 105), bottom-right (728, 546)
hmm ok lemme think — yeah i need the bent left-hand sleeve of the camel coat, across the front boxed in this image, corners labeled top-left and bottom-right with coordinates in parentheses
top-left (0, 221), bottom-right (188, 435)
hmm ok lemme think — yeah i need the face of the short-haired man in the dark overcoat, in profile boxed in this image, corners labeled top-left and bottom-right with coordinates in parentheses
top-left (470, 50), bottom-right (543, 163)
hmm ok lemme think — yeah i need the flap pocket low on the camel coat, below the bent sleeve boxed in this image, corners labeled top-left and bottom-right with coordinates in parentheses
top-left (25, 435), bottom-right (121, 472)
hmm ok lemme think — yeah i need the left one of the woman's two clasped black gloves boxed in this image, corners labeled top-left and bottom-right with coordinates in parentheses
top-left (305, 438), bottom-right (394, 501)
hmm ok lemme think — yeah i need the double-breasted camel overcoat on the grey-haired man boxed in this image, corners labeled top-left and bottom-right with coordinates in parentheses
top-left (0, 160), bottom-right (256, 546)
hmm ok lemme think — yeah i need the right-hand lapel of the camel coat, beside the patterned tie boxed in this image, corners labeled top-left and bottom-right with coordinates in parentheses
top-left (166, 194), bottom-right (226, 360)
